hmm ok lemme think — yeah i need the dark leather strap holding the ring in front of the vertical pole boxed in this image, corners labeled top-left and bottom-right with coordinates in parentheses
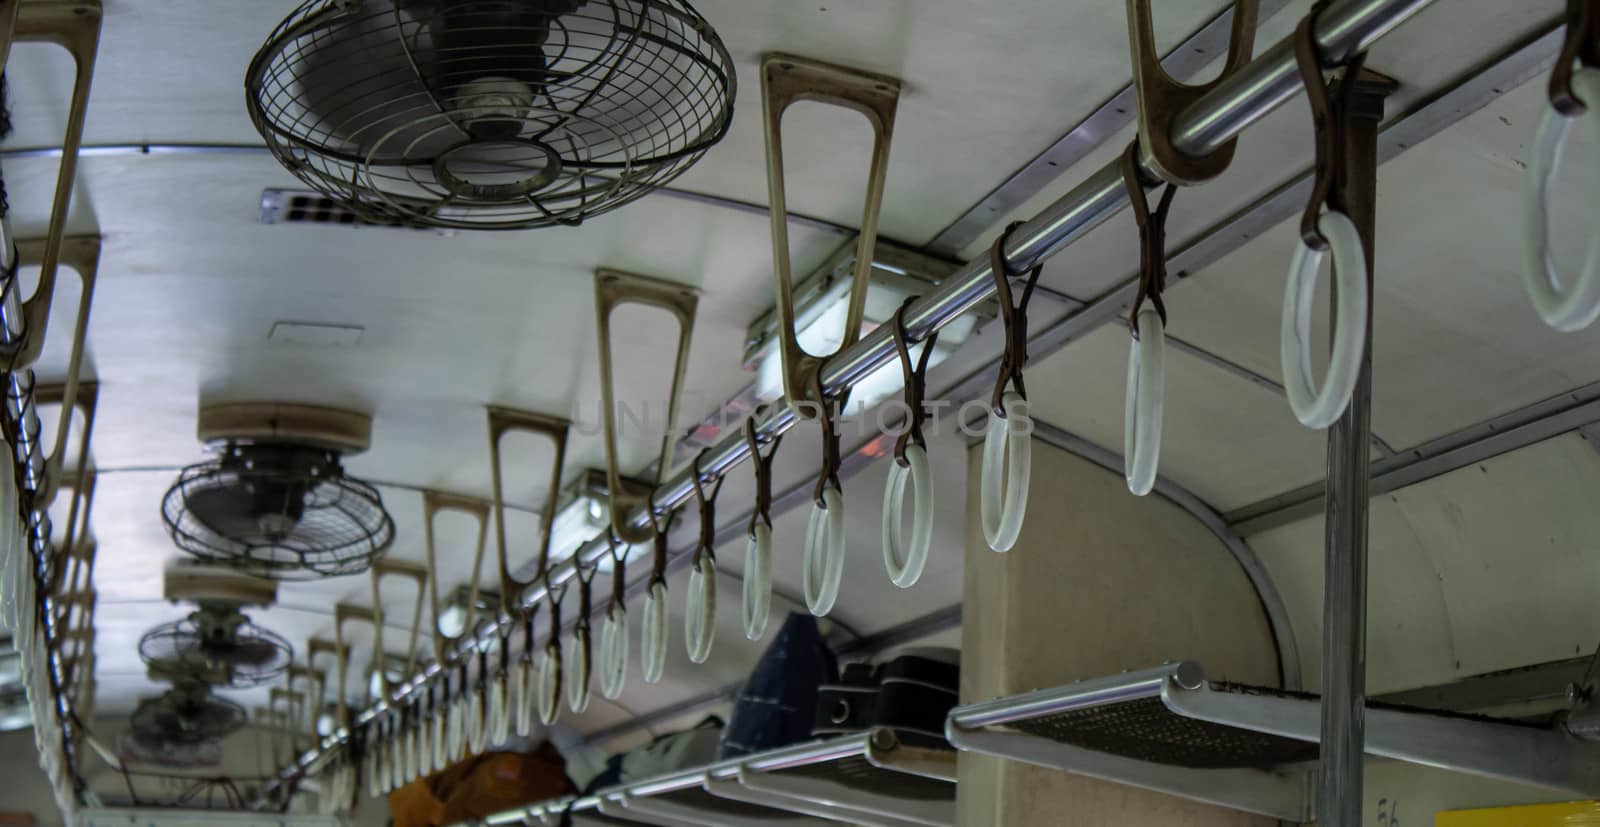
top-left (1294, 0), bottom-right (1366, 251)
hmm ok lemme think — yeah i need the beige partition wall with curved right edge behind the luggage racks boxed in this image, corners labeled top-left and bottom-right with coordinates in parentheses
top-left (957, 440), bottom-right (1278, 827)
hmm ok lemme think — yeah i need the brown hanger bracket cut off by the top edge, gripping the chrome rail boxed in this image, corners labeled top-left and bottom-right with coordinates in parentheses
top-left (1128, 0), bottom-right (1258, 184)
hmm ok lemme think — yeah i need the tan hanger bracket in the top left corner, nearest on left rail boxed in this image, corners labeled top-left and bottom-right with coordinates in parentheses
top-left (0, 0), bottom-right (101, 366)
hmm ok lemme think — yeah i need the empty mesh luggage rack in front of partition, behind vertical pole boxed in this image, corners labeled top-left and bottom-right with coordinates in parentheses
top-left (946, 661), bottom-right (1600, 821)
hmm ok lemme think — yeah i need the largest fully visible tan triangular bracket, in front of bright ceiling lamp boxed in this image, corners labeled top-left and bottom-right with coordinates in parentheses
top-left (762, 54), bottom-right (899, 417)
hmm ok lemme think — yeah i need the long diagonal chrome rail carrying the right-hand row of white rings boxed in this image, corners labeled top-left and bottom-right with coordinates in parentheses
top-left (266, 0), bottom-right (1434, 792)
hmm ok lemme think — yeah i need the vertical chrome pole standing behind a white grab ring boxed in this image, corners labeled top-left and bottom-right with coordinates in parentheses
top-left (1317, 72), bottom-right (1394, 827)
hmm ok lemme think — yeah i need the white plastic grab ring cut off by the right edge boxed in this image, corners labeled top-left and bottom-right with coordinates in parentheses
top-left (1522, 67), bottom-right (1600, 333)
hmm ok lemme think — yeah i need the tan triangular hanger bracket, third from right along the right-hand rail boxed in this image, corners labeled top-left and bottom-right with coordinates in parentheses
top-left (595, 270), bottom-right (699, 544)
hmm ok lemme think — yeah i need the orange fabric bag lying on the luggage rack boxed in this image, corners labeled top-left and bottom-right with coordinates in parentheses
top-left (389, 742), bottom-right (574, 827)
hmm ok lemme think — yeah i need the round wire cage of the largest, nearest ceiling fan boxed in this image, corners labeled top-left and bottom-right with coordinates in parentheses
top-left (246, 0), bottom-right (736, 229)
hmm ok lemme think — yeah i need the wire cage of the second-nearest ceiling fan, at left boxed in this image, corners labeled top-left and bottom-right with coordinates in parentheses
top-left (162, 443), bottom-right (395, 581)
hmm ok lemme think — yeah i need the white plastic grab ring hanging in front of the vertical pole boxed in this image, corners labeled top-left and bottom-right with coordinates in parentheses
top-left (1278, 211), bottom-right (1366, 429)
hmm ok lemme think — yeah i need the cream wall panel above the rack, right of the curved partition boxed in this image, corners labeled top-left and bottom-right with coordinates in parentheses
top-left (1250, 433), bottom-right (1600, 693)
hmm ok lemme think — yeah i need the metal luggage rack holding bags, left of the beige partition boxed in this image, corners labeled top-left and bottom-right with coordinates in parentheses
top-left (483, 729), bottom-right (955, 827)
